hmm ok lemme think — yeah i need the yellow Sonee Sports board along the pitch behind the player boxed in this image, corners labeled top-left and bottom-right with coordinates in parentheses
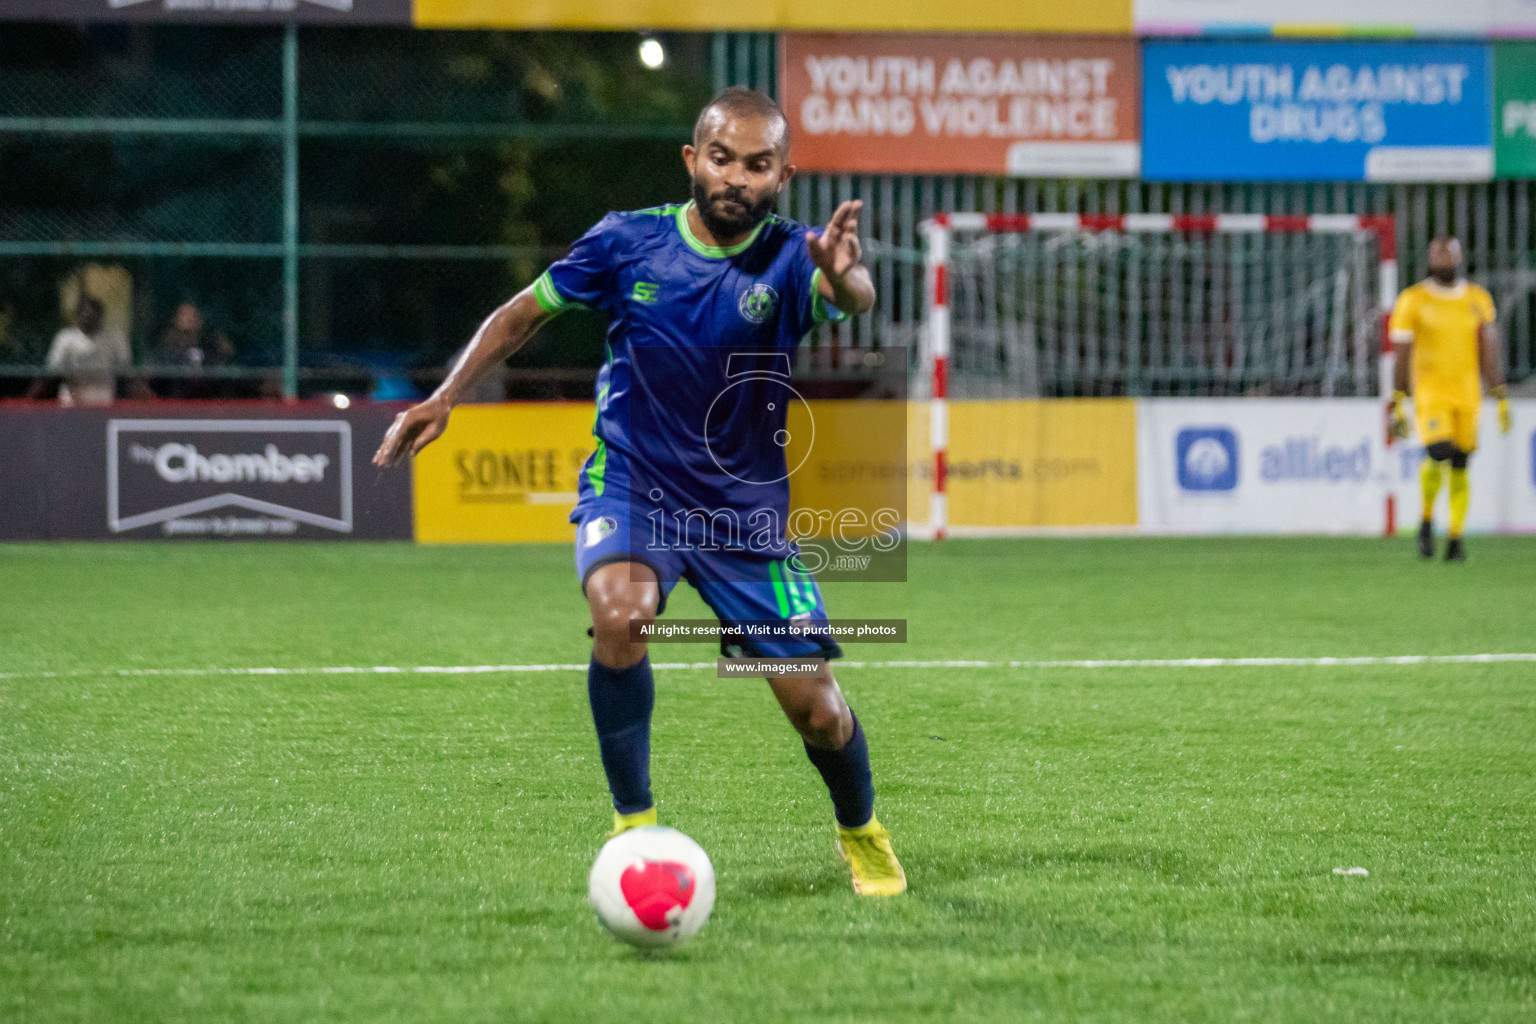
top-left (415, 399), bottom-right (1137, 543)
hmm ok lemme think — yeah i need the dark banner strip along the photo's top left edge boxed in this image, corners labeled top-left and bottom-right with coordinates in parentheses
top-left (0, 0), bottom-right (412, 25)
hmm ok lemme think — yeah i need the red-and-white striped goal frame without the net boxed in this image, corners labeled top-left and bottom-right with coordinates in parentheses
top-left (917, 213), bottom-right (1398, 539)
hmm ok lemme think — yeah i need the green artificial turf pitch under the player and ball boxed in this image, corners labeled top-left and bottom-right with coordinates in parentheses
top-left (0, 537), bottom-right (1536, 1024)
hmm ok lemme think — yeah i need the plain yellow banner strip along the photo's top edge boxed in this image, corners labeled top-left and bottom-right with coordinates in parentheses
top-left (415, 0), bottom-right (1130, 34)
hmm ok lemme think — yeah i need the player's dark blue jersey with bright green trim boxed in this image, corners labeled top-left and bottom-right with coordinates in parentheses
top-left (535, 196), bottom-right (845, 540)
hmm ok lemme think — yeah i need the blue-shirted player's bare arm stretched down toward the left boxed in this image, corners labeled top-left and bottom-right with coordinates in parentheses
top-left (373, 284), bottom-right (554, 467)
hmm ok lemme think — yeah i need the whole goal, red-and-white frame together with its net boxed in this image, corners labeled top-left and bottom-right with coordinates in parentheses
top-left (917, 212), bottom-right (1398, 539)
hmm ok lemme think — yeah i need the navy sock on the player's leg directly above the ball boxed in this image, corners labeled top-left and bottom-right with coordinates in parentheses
top-left (587, 656), bottom-right (656, 814)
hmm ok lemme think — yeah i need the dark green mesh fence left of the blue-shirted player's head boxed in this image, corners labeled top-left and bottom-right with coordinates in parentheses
top-left (0, 25), bottom-right (711, 396)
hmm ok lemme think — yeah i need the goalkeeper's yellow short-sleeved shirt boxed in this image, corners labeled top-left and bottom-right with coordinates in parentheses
top-left (1387, 281), bottom-right (1493, 405)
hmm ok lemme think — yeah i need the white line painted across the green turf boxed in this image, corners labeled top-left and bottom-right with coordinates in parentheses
top-left (0, 652), bottom-right (1536, 679)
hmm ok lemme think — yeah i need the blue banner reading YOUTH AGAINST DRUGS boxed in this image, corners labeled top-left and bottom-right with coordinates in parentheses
top-left (1141, 43), bottom-right (1493, 181)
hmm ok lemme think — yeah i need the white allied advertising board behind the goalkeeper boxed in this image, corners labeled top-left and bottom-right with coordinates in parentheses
top-left (1137, 398), bottom-right (1536, 536)
